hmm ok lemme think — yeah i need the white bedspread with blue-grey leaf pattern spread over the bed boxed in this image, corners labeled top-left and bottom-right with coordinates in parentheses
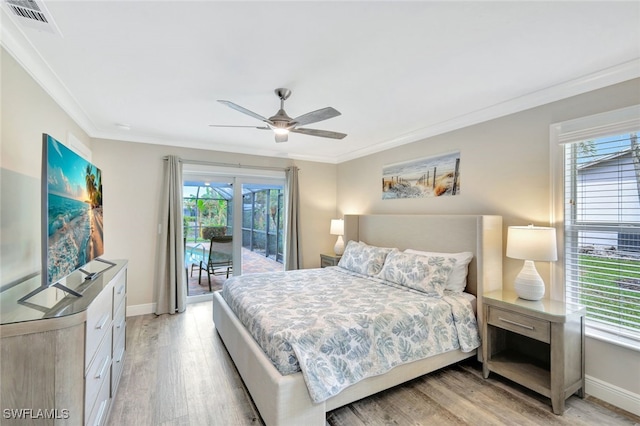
top-left (222, 267), bottom-right (480, 402)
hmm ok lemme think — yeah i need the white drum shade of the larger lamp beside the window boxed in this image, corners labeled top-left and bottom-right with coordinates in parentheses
top-left (507, 225), bottom-right (558, 261)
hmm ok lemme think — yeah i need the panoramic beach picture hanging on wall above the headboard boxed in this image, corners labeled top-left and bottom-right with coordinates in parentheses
top-left (382, 151), bottom-right (460, 200)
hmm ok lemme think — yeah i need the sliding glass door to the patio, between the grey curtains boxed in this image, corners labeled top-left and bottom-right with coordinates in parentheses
top-left (183, 164), bottom-right (285, 297)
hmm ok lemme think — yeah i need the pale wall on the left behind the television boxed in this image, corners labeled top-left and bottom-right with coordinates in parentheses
top-left (0, 48), bottom-right (91, 286)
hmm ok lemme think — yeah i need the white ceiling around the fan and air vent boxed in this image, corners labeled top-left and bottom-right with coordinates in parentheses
top-left (1, 0), bottom-right (640, 163)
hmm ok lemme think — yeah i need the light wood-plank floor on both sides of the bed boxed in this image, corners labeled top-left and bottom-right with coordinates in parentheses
top-left (109, 302), bottom-right (640, 426)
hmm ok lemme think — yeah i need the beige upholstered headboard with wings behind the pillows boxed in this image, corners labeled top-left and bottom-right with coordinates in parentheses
top-left (344, 215), bottom-right (502, 320)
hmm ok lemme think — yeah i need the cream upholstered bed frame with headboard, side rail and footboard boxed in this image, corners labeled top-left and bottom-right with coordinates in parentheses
top-left (213, 215), bottom-right (502, 426)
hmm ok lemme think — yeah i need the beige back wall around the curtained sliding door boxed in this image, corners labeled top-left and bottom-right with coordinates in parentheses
top-left (93, 139), bottom-right (336, 314)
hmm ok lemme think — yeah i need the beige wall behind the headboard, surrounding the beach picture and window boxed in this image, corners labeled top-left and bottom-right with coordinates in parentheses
top-left (337, 79), bottom-right (640, 415)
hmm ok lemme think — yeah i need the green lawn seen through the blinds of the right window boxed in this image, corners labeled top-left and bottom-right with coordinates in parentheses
top-left (579, 255), bottom-right (640, 331)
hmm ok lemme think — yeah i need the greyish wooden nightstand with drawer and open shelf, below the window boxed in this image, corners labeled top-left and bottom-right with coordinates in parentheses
top-left (482, 291), bottom-right (586, 414)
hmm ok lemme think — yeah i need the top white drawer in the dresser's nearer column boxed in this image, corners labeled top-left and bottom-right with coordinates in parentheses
top-left (84, 284), bottom-right (113, 372)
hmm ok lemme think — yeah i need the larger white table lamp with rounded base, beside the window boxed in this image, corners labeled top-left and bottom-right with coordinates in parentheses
top-left (507, 225), bottom-right (558, 300)
